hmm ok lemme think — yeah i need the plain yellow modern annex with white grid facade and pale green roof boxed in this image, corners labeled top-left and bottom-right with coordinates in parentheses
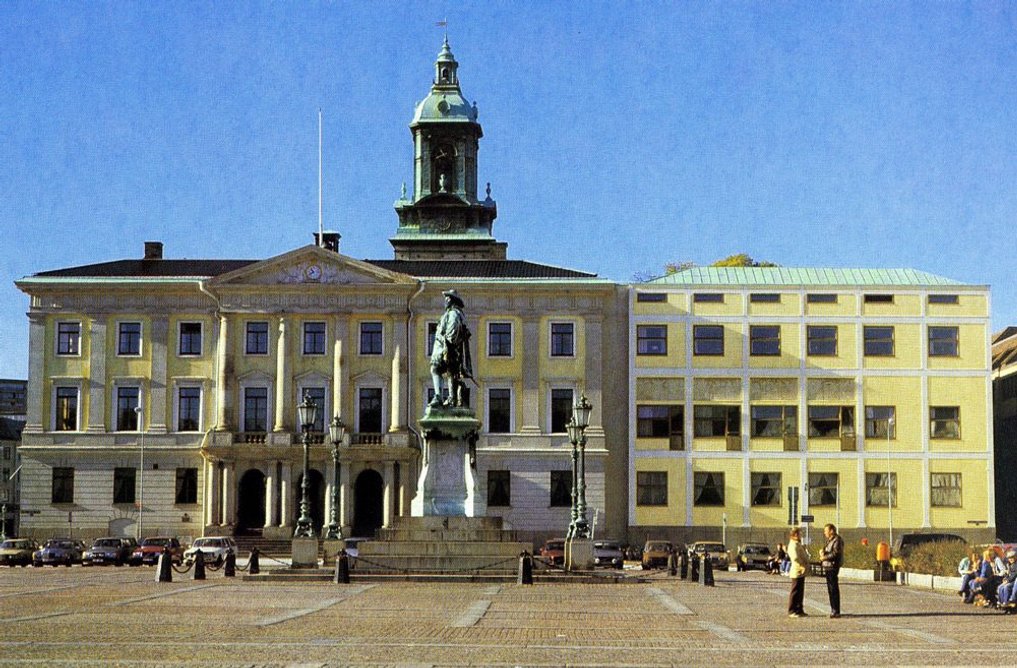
top-left (629, 267), bottom-right (995, 545)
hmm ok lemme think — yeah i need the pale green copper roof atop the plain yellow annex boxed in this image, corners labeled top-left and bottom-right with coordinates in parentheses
top-left (647, 266), bottom-right (966, 287)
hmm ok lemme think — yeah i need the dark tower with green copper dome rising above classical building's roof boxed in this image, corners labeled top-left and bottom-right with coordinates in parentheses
top-left (388, 38), bottom-right (507, 260)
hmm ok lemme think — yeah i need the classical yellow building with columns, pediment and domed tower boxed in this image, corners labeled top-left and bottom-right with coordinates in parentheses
top-left (16, 43), bottom-right (627, 538)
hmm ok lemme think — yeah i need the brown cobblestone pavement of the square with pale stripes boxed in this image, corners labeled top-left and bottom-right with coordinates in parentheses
top-left (0, 566), bottom-right (1017, 666)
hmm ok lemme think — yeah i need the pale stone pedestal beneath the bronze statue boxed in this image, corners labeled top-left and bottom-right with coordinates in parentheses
top-left (411, 407), bottom-right (480, 518)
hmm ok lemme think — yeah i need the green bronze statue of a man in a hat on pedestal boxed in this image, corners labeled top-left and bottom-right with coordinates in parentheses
top-left (430, 289), bottom-right (473, 407)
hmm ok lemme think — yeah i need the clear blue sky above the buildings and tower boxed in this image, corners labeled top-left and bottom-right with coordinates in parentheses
top-left (0, 2), bottom-right (1017, 378)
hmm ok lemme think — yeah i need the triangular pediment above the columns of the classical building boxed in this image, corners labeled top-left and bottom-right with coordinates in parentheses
top-left (212, 245), bottom-right (414, 287)
